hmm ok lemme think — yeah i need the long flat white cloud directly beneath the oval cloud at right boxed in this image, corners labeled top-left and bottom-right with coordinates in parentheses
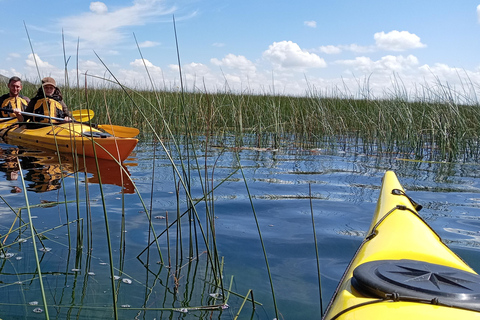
top-left (337, 55), bottom-right (418, 74)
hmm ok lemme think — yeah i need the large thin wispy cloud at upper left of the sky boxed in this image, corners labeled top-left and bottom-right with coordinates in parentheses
top-left (58, 0), bottom-right (175, 48)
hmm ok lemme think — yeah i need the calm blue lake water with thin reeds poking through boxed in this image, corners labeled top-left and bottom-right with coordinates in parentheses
top-left (0, 144), bottom-right (480, 319)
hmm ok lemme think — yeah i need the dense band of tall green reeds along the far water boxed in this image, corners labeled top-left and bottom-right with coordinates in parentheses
top-left (15, 78), bottom-right (480, 161)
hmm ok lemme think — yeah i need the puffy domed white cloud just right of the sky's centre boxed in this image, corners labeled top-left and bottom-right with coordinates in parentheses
top-left (263, 41), bottom-right (327, 70)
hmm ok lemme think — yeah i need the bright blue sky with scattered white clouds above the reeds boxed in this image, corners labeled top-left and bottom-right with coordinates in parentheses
top-left (0, 0), bottom-right (480, 98)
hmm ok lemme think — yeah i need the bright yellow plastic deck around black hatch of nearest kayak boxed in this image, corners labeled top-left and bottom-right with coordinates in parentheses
top-left (324, 171), bottom-right (480, 320)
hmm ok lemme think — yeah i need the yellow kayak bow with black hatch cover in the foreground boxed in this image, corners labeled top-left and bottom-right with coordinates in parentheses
top-left (324, 171), bottom-right (480, 320)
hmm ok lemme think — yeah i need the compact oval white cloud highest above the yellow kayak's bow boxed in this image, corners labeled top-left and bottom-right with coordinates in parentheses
top-left (373, 30), bottom-right (426, 51)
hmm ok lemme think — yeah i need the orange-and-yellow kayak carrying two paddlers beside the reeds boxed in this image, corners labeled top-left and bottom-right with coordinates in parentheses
top-left (0, 123), bottom-right (138, 161)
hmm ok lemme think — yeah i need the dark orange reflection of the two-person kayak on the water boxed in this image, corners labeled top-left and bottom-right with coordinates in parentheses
top-left (0, 144), bottom-right (135, 193)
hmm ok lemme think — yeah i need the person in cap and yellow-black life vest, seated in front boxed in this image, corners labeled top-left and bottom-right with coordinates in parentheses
top-left (15, 77), bottom-right (72, 123)
